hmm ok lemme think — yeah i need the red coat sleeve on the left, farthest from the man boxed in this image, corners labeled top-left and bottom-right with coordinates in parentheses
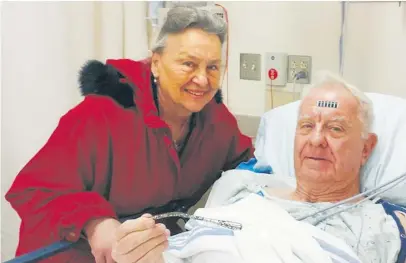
top-left (5, 100), bottom-right (116, 248)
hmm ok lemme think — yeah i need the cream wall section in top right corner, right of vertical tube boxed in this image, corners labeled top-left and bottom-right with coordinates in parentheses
top-left (344, 2), bottom-right (406, 98)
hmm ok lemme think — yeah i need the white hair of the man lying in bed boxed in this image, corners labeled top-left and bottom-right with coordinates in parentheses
top-left (302, 71), bottom-right (374, 139)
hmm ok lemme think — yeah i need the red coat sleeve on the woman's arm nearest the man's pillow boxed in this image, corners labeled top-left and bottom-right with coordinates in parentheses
top-left (223, 110), bottom-right (254, 171)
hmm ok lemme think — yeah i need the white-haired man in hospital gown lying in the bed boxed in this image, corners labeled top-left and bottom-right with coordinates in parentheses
top-left (115, 76), bottom-right (406, 263)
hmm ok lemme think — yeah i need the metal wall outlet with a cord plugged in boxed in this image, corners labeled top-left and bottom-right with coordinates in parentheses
top-left (288, 55), bottom-right (312, 84)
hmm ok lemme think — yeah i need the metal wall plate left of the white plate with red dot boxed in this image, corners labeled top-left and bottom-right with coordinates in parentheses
top-left (240, 53), bottom-right (261, 81)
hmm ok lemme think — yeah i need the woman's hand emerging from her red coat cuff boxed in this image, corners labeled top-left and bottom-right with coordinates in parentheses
top-left (84, 218), bottom-right (120, 263)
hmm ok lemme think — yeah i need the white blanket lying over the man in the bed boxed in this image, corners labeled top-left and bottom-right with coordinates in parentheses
top-left (164, 194), bottom-right (361, 263)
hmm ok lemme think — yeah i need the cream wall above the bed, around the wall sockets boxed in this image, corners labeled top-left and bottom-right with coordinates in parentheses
top-left (219, 1), bottom-right (406, 116)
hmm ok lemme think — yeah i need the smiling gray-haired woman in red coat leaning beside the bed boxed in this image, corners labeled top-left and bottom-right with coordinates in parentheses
top-left (6, 7), bottom-right (253, 263)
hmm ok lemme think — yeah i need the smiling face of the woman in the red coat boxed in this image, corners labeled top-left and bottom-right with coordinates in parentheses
top-left (152, 28), bottom-right (221, 113)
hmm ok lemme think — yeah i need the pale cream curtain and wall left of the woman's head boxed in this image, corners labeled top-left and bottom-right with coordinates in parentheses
top-left (1, 2), bottom-right (148, 261)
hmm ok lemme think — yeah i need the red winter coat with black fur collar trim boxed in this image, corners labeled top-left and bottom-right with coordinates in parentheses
top-left (6, 60), bottom-right (253, 263)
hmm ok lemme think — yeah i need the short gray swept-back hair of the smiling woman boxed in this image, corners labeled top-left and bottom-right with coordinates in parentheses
top-left (152, 6), bottom-right (227, 53)
